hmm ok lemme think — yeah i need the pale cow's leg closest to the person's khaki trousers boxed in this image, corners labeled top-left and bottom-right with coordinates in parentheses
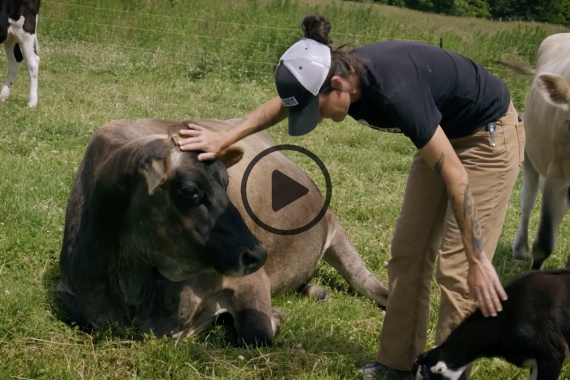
top-left (512, 152), bottom-right (539, 260)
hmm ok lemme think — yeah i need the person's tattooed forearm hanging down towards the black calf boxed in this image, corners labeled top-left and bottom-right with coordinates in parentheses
top-left (447, 170), bottom-right (484, 264)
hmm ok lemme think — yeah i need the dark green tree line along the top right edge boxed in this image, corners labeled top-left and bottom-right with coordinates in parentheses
top-left (348, 0), bottom-right (570, 26)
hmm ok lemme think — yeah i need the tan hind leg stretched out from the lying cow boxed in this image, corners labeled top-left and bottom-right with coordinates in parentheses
top-left (323, 213), bottom-right (388, 308)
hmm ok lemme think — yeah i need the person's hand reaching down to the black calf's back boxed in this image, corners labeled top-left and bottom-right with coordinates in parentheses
top-left (467, 253), bottom-right (507, 317)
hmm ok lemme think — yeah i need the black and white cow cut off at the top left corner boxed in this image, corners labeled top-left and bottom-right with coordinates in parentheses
top-left (0, 0), bottom-right (41, 107)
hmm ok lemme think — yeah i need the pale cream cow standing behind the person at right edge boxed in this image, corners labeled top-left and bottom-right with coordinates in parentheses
top-left (500, 33), bottom-right (570, 269)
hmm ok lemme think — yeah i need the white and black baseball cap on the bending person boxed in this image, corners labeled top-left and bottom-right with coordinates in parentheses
top-left (275, 38), bottom-right (331, 136)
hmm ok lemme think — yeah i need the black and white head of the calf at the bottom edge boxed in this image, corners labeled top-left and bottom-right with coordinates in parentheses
top-left (412, 347), bottom-right (469, 380)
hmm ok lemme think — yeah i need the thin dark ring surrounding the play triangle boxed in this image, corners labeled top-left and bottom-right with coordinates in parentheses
top-left (240, 144), bottom-right (332, 235)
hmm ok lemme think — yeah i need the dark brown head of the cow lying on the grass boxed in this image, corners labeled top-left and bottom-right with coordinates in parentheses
top-left (122, 133), bottom-right (267, 281)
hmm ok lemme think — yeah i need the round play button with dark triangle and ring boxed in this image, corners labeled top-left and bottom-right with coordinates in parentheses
top-left (241, 144), bottom-right (332, 235)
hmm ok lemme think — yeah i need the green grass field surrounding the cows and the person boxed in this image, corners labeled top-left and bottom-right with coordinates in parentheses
top-left (0, 0), bottom-right (570, 380)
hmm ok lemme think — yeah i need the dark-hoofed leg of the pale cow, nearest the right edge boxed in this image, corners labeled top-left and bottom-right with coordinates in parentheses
top-left (531, 160), bottom-right (568, 270)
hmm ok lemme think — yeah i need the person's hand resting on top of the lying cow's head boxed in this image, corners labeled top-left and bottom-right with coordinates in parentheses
top-left (178, 124), bottom-right (224, 161)
